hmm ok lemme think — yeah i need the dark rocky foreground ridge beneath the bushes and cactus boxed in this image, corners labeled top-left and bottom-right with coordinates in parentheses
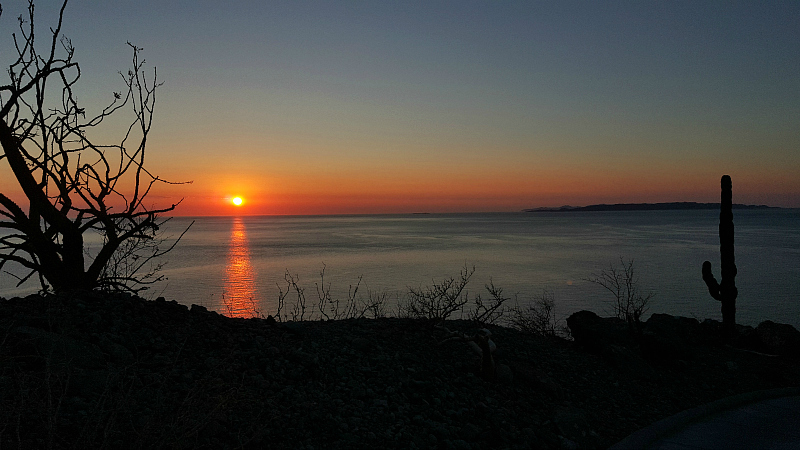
top-left (0, 293), bottom-right (800, 449)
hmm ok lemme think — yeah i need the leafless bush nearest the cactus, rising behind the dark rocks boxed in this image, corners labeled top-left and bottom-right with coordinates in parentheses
top-left (587, 256), bottom-right (655, 328)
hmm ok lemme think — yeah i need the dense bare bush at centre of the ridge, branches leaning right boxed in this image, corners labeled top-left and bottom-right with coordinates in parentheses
top-left (398, 266), bottom-right (475, 321)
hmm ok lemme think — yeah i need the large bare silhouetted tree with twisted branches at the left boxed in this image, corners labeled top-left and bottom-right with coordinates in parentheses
top-left (0, 0), bottom-right (188, 291)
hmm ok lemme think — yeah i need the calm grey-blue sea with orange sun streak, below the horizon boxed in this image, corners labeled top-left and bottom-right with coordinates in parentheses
top-left (0, 209), bottom-right (800, 327)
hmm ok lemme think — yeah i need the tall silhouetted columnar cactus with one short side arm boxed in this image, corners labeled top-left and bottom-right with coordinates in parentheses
top-left (703, 175), bottom-right (739, 340)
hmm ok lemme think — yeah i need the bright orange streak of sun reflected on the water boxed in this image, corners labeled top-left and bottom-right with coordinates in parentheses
top-left (224, 217), bottom-right (258, 317)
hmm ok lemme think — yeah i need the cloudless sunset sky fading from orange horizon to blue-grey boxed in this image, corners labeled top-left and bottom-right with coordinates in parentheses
top-left (0, 0), bottom-right (800, 215)
